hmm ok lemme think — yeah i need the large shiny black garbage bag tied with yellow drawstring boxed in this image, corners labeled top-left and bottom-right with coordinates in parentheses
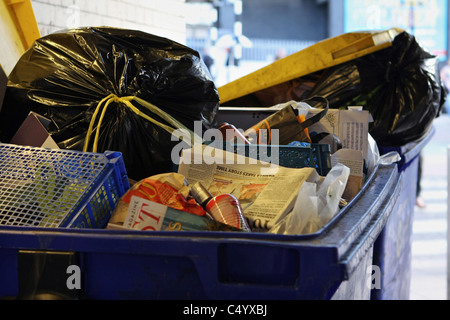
top-left (0, 27), bottom-right (219, 180)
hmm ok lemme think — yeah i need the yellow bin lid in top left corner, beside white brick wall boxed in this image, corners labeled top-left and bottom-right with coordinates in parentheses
top-left (0, 0), bottom-right (40, 75)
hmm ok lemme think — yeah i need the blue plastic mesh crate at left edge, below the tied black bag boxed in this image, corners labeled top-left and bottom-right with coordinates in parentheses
top-left (0, 144), bottom-right (129, 228)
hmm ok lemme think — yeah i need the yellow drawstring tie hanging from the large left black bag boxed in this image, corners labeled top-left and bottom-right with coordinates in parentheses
top-left (83, 94), bottom-right (203, 152)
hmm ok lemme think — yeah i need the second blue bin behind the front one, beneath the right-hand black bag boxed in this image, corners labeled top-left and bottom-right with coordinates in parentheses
top-left (372, 128), bottom-right (434, 300)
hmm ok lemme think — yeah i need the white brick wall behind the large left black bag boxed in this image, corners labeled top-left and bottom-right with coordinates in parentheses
top-left (31, 0), bottom-right (186, 44)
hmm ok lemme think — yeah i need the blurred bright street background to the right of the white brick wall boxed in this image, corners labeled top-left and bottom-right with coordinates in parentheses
top-left (186, 0), bottom-right (449, 84)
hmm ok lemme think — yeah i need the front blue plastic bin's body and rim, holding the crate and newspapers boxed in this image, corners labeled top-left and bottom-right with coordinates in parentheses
top-left (0, 164), bottom-right (401, 300)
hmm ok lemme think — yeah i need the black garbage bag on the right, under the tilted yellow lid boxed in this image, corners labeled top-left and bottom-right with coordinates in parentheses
top-left (310, 32), bottom-right (445, 147)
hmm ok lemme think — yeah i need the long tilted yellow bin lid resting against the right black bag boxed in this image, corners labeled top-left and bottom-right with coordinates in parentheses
top-left (218, 28), bottom-right (403, 105)
